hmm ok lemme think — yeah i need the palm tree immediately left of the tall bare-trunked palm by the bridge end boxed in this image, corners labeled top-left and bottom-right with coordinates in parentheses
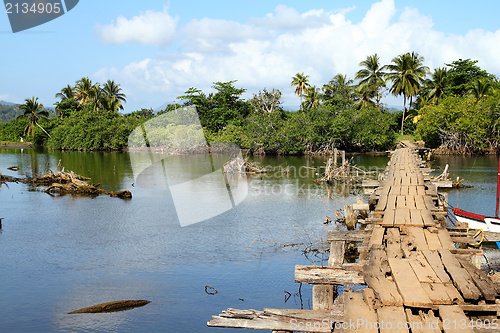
top-left (354, 53), bottom-right (386, 111)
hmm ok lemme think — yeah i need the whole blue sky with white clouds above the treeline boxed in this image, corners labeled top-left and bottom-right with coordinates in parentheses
top-left (0, 0), bottom-right (500, 112)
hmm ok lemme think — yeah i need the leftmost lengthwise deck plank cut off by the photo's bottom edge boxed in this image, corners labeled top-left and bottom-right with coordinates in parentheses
top-left (344, 292), bottom-right (378, 333)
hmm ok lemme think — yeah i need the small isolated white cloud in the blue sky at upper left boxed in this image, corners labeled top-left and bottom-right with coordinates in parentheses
top-left (95, 7), bottom-right (179, 45)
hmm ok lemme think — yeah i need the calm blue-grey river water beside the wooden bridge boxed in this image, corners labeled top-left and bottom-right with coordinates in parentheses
top-left (0, 150), bottom-right (497, 332)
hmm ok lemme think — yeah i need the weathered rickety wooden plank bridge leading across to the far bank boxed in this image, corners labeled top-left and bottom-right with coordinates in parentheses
top-left (208, 148), bottom-right (500, 333)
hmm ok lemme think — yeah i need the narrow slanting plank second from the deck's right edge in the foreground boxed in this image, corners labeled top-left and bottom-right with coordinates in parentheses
top-left (439, 249), bottom-right (482, 301)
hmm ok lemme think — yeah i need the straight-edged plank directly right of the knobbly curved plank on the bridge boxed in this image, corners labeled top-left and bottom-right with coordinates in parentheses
top-left (388, 258), bottom-right (432, 308)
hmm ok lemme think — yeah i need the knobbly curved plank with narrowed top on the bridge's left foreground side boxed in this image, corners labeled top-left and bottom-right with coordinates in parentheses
top-left (363, 246), bottom-right (403, 306)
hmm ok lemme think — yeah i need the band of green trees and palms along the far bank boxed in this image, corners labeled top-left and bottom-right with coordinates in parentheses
top-left (0, 52), bottom-right (500, 154)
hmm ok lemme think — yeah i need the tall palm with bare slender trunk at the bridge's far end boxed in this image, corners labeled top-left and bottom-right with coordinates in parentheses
top-left (384, 52), bottom-right (429, 135)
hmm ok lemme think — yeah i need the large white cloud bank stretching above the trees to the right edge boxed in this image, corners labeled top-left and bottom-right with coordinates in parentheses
top-left (96, 0), bottom-right (500, 111)
